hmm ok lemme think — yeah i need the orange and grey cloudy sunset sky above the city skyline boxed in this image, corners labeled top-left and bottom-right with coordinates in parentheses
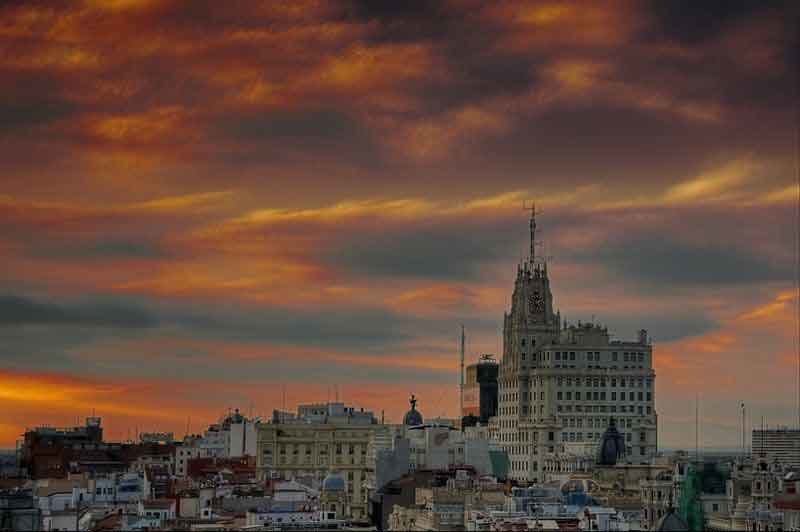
top-left (0, 0), bottom-right (800, 447)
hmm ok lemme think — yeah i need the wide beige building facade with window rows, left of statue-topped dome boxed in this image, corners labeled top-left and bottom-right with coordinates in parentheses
top-left (256, 423), bottom-right (380, 519)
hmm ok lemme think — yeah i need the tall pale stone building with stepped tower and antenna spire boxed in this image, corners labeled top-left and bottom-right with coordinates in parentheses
top-left (490, 210), bottom-right (657, 482)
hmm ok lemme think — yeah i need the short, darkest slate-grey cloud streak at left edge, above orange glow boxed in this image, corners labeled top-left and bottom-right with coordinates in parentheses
top-left (0, 295), bottom-right (158, 329)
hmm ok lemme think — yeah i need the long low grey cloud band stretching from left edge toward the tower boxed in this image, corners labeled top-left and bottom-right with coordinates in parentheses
top-left (0, 295), bottom-right (456, 352)
